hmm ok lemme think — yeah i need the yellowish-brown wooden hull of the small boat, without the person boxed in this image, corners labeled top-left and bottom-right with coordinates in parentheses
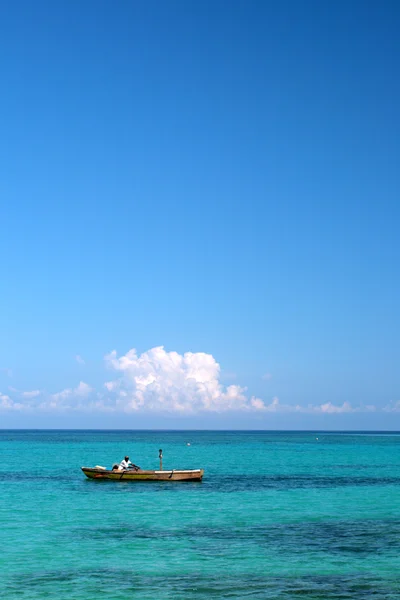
top-left (81, 467), bottom-right (204, 481)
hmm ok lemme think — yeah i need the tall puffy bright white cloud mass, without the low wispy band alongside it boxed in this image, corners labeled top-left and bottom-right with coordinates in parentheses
top-left (105, 346), bottom-right (265, 414)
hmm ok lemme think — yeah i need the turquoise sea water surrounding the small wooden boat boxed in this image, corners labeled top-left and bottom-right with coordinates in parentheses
top-left (0, 430), bottom-right (400, 600)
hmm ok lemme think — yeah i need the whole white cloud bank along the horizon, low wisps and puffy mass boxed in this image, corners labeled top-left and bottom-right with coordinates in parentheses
top-left (0, 346), bottom-right (382, 414)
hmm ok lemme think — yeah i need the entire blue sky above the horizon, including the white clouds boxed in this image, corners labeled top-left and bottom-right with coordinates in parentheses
top-left (0, 0), bottom-right (400, 429)
